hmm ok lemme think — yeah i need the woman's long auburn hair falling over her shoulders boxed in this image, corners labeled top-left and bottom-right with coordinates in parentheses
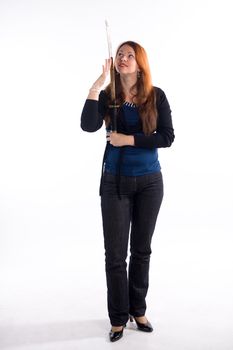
top-left (105, 41), bottom-right (158, 135)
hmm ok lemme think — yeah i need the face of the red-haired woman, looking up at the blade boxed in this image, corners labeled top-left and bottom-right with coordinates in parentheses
top-left (115, 45), bottom-right (138, 75)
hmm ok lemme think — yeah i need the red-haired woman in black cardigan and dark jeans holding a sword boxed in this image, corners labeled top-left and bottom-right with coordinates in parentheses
top-left (81, 41), bottom-right (174, 342)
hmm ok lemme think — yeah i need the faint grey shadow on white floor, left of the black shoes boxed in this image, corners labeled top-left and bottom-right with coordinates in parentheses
top-left (0, 320), bottom-right (109, 348)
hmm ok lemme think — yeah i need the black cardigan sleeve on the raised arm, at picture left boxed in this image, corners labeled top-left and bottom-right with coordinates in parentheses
top-left (81, 91), bottom-right (106, 132)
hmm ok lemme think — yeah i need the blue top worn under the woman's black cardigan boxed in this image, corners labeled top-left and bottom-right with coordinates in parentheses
top-left (104, 102), bottom-right (161, 176)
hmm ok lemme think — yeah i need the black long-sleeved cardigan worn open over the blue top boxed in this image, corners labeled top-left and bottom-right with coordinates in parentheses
top-left (81, 87), bottom-right (175, 149)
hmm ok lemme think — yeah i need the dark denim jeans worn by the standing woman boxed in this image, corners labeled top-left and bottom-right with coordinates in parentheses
top-left (101, 172), bottom-right (163, 326)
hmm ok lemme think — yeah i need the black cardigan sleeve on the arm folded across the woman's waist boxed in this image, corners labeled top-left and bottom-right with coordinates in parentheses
top-left (134, 87), bottom-right (175, 149)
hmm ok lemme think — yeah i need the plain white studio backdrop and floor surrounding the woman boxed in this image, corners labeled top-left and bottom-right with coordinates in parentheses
top-left (0, 0), bottom-right (233, 350)
